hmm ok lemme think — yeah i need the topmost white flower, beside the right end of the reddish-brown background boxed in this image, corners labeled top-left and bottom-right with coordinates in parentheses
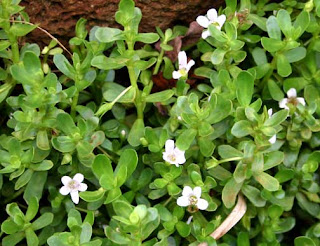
top-left (196, 9), bottom-right (226, 39)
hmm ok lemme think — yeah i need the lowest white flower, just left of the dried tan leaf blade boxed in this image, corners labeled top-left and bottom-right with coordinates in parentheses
top-left (177, 186), bottom-right (209, 210)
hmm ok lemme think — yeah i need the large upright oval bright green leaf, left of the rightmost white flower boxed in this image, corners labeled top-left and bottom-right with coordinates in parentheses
top-left (235, 71), bottom-right (254, 106)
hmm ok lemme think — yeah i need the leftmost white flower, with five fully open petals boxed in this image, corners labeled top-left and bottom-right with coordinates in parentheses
top-left (60, 173), bottom-right (88, 204)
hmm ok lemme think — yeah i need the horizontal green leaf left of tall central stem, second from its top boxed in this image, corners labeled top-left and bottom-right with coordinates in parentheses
top-left (91, 55), bottom-right (129, 70)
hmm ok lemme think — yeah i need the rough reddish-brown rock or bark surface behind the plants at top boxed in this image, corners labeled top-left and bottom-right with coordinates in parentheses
top-left (22, 0), bottom-right (224, 43)
